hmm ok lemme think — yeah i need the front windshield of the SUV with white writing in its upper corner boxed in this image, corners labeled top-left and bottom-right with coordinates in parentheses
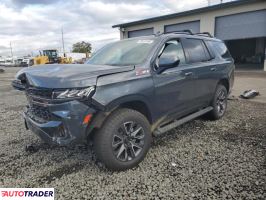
top-left (87, 38), bottom-right (155, 66)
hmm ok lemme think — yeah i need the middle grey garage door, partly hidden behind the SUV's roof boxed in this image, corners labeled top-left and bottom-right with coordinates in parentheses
top-left (164, 21), bottom-right (200, 33)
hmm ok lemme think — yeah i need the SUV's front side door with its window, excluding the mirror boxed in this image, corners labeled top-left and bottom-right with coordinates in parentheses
top-left (153, 39), bottom-right (195, 119)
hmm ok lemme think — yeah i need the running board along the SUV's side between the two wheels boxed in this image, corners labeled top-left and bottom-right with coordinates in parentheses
top-left (153, 106), bottom-right (213, 136)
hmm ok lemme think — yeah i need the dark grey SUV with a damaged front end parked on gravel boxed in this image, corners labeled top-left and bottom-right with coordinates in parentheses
top-left (12, 32), bottom-right (235, 170)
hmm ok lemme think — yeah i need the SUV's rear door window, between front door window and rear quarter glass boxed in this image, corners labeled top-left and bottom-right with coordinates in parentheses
top-left (182, 38), bottom-right (211, 63)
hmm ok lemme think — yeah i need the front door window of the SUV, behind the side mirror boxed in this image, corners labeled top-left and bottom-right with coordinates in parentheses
top-left (158, 40), bottom-right (186, 65)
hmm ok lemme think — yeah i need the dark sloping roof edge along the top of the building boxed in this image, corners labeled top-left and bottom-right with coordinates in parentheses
top-left (112, 0), bottom-right (265, 28)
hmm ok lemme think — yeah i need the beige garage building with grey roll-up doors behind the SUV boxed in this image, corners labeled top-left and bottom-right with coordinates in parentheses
top-left (113, 0), bottom-right (266, 71)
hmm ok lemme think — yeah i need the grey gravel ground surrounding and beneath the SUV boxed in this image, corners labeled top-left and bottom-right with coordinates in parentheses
top-left (0, 69), bottom-right (266, 199)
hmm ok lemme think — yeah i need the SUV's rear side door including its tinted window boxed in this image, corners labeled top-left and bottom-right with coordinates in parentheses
top-left (182, 38), bottom-right (216, 108)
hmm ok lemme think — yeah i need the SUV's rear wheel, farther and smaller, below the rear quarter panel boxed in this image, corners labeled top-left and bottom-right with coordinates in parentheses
top-left (207, 84), bottom-right (228, 120)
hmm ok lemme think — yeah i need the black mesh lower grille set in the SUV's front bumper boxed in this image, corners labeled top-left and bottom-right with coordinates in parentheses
top-left (27, 104), bottom-right (52, 123)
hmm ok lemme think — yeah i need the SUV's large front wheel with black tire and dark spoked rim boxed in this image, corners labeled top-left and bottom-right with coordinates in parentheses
top-left (93, 108), bottom-right (152, 171)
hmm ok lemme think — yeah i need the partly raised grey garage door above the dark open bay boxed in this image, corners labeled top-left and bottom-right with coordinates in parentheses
top-left (215, 10), bottom-right (266, 40)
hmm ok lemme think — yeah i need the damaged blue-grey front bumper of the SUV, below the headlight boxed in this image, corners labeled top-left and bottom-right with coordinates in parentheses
top-left (23, 100), bottom-right (96, 146)
